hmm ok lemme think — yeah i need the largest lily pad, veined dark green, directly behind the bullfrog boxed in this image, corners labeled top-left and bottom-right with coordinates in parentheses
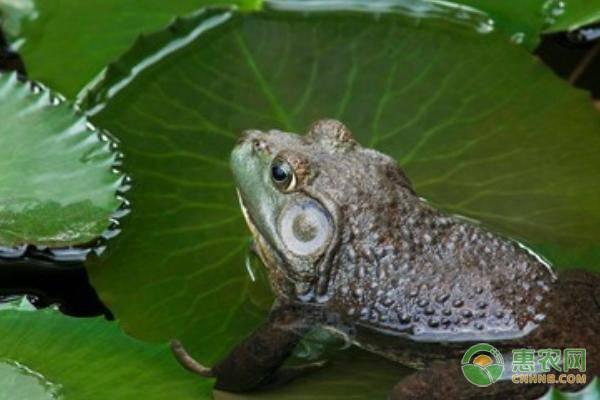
top-left (83, 5), bottom-right (600, 391)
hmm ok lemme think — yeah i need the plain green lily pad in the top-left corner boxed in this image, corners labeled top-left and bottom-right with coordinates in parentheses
top-left (0, 0), bottom-right (259, 98)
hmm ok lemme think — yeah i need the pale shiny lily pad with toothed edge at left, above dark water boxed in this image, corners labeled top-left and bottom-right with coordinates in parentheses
top-left (0, 74), bottom-right (122, 247)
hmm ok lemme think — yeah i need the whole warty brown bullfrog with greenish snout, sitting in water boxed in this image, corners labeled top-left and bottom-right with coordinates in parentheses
top-left (172, 119), bottom-right (600, 399)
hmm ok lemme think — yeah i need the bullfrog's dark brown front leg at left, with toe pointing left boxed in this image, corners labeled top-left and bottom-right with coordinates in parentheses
top-left (171, 306), bottom-right (312, 392)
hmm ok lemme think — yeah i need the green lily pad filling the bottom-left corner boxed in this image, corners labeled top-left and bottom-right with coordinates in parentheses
top-left (0, 303), bottom-right (211, 400)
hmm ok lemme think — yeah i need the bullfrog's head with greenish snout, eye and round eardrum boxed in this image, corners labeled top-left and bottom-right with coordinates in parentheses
top-left (231, 120), bottom-right (412, 299)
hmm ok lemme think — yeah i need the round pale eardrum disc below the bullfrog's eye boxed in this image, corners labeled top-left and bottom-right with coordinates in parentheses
top-left (279, 199), bottom-right (333, 256)
